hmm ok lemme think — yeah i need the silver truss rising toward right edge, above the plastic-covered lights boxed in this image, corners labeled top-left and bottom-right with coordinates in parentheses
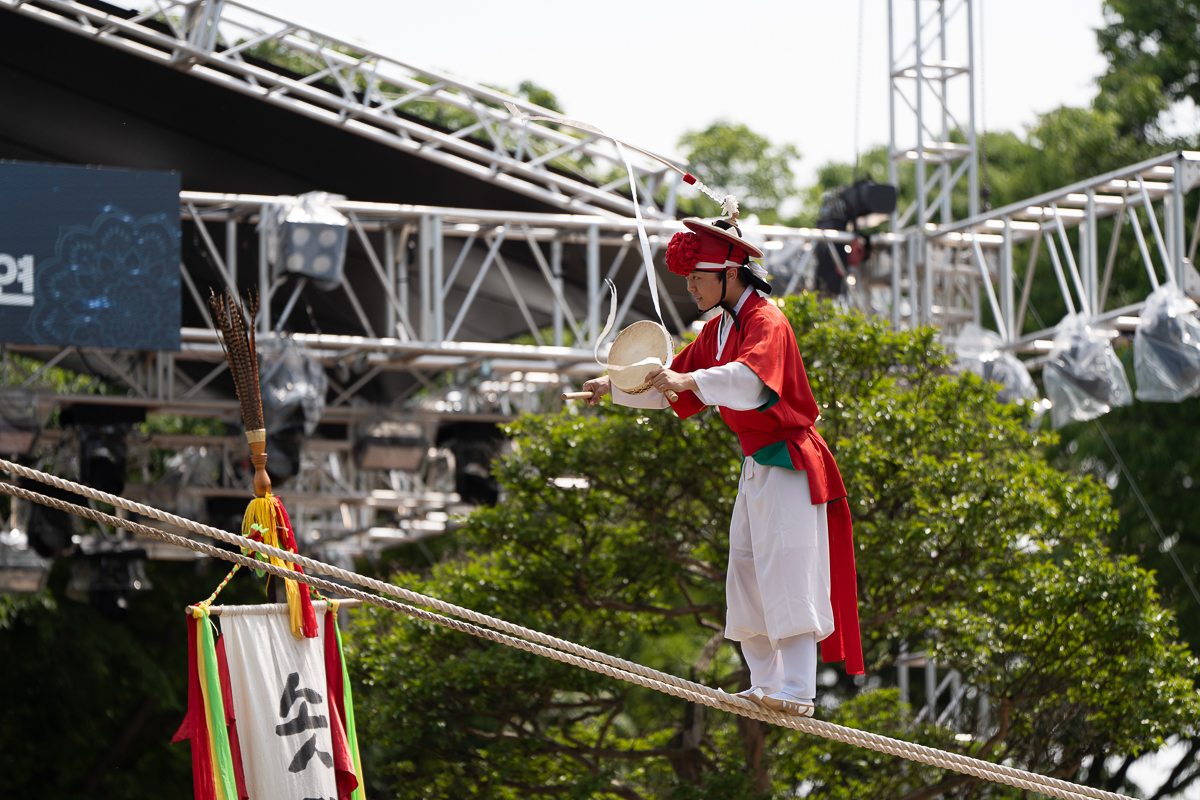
top-left (870, 151), bottom-right (1200, 357)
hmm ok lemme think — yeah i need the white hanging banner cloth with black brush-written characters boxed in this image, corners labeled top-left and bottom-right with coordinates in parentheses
top-left (221, 614), bottom-right (337, 800)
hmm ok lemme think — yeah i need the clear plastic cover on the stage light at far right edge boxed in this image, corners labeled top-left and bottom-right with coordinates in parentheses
top-left (1133, 283), bottom-right (1200, 403)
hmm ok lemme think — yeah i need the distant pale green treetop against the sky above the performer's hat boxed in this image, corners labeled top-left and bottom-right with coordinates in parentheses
top-left (679, 120), bottom-right (800, 224)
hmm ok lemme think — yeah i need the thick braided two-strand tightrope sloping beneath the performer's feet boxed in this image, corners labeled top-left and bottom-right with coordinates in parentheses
top-left (0, 459), bottom-right (1128, 800)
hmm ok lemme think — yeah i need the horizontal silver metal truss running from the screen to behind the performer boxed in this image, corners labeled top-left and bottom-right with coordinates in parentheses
top-left (4, 192), bottom-right (853, 421)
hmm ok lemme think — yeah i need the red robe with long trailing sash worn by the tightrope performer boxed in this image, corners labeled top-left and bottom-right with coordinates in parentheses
top-left (671, 291), bottom-right (863, 675)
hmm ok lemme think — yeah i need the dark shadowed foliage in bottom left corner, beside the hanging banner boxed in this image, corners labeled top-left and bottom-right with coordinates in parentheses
top-left (0, 559), bottom-right (263, 800)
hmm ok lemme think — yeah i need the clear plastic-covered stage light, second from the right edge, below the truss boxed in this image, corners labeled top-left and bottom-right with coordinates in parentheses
top-left (1043, 314), bottom-right (1133, 428)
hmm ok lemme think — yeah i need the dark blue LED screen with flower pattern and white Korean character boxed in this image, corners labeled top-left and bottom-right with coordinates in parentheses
top-left (0, 161), bottom-right (180, 350)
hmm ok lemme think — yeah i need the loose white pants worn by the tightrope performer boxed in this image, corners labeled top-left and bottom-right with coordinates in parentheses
top-left (725, 458), bottom-right (834, 697)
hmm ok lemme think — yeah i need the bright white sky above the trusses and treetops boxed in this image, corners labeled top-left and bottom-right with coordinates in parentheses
top-left (220, 0), bottom-right (1105, 186)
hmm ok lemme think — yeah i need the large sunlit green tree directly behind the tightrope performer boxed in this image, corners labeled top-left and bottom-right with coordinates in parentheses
top-left (352, 296), bottom-right (1200, 799)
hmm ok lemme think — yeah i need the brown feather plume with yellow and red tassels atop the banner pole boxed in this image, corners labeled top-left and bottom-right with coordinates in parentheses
top-left (209, 290), bottom-right (318, 639)
